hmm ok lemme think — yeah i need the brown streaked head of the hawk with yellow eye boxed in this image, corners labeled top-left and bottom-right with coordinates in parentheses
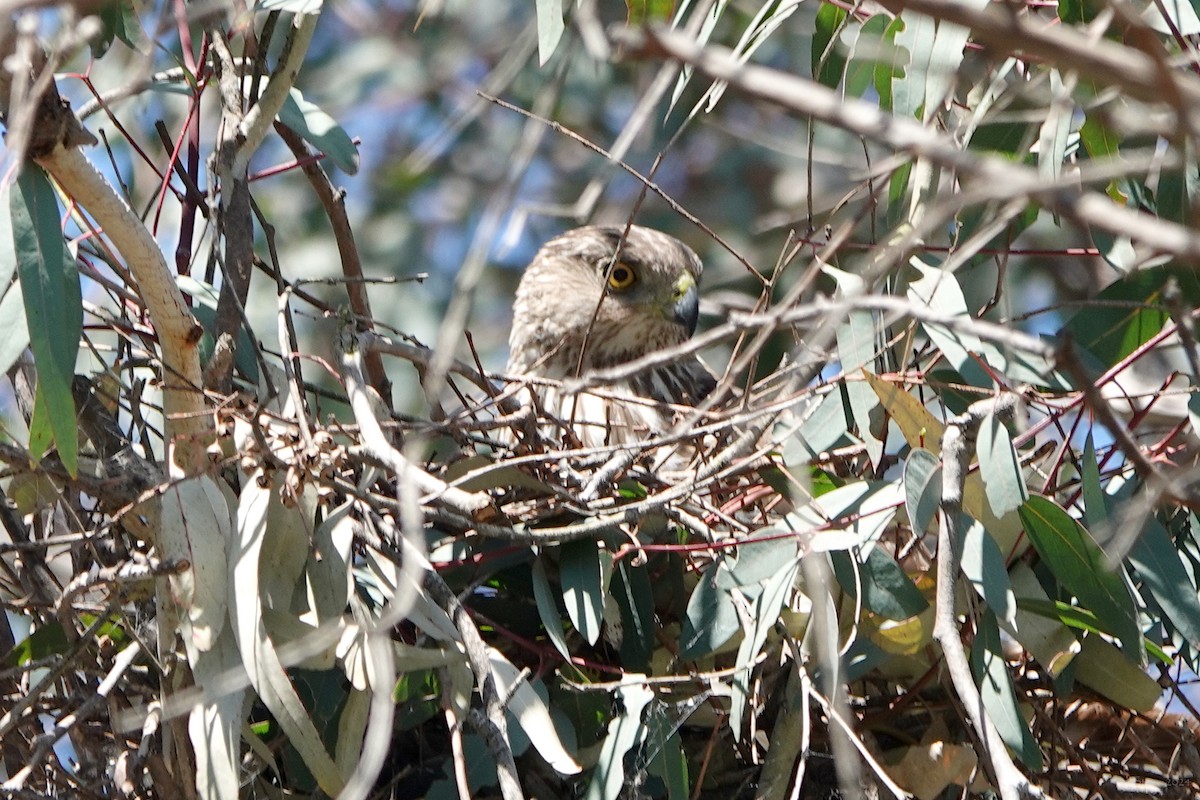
top-left (509, 225), bottom-right (701, 378)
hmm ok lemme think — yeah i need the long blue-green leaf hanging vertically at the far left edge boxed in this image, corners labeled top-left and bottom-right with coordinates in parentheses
top-left (10, 164), bottom-right (83, 476)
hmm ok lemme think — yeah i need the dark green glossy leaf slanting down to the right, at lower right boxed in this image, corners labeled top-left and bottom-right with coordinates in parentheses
top-left (1020, 494), bottom-right (1145, 664)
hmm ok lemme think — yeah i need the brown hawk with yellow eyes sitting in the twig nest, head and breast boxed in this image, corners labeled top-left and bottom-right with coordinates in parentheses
top-left (508, 225), bottom-right (715, 446)
